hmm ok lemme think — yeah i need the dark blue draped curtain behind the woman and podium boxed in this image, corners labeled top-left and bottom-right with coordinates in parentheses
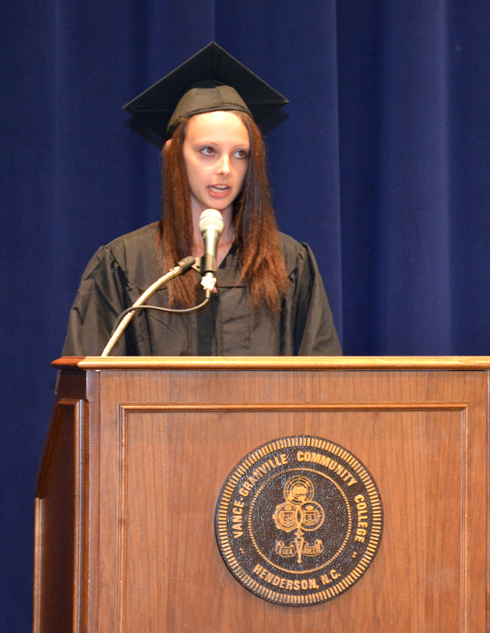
top-left (0, 0), bottom-right (490, 633)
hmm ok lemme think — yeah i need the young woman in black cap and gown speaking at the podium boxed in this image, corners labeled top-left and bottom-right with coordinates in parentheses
top-left (63, 44), bottom-right (341, 356)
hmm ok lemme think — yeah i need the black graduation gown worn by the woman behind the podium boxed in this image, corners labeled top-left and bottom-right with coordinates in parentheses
top-left (63, 223), bottom-right (341, 356)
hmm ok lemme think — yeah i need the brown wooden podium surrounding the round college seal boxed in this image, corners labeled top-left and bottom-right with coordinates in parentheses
top-left (34, 357), bottom-right (490, 633)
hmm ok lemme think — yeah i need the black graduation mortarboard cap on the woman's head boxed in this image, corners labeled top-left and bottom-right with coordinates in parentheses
top-left (124, 42), bottom-right (289, 138)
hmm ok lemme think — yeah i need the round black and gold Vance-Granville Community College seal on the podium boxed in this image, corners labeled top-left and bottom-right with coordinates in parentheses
top-left (215, 435), bottom-right (383, 606)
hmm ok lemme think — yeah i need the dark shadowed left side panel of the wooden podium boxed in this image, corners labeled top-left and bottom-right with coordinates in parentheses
top-left (34, 399), bottom-right (88, 633)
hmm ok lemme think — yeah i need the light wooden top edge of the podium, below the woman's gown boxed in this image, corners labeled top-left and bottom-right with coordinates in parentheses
top-left (52, 356), bottom-right (490, 371)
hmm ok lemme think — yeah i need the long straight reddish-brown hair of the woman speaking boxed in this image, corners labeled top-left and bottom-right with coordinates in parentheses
top-left (160, 111), bottom-right (288, 312)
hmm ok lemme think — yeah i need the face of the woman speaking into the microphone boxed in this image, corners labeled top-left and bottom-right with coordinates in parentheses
top-left (183, 111), bottom-right (250, 220)
